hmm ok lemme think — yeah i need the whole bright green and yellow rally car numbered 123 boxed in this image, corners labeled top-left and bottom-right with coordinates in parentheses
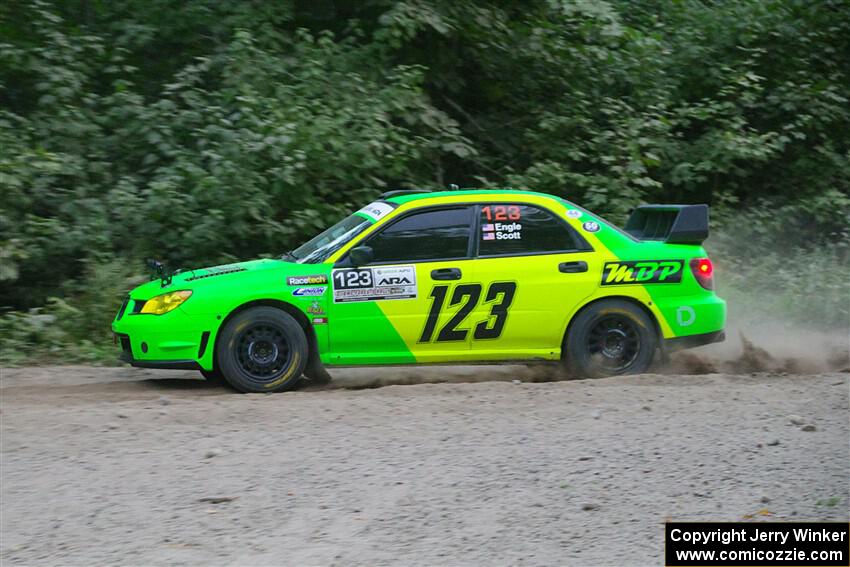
top-left (112, 190), bottom-right (726, 392)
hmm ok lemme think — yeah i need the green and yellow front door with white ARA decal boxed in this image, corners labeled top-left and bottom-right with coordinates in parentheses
top-left (329, 205), bottom-right (477, 364)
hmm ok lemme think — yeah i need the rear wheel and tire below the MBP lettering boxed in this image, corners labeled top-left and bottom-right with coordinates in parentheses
top-left (564, 299), bottom-right (658, 378)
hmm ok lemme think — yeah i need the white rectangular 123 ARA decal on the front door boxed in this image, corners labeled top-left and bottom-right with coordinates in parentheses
top-left (331, 266), bottom-right (416, 303)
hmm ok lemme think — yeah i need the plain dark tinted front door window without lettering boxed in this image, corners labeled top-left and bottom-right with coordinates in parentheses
top-left (367, 207), bottom-right (473, 263)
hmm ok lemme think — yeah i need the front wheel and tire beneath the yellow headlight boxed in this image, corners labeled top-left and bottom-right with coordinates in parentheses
top-left (216, 307), bottom-right (308, 393)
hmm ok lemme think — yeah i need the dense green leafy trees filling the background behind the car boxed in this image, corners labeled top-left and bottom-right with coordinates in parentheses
top-left (0, 0), bottom-right (850, 364)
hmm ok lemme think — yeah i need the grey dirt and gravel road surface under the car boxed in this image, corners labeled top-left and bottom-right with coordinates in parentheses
top-left (0, 356), bottom-right (850, 565)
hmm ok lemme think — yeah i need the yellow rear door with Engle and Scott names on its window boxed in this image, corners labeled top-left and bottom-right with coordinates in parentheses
top-left (470, 203), bottom-right (602, 360)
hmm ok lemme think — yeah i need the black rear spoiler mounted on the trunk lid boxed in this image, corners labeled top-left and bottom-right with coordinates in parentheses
top-left (625, 205), bottom-right (708, 244)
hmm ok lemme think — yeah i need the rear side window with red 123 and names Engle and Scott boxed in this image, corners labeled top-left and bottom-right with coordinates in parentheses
top-left (478, 203), bottom-right (589, 256)
